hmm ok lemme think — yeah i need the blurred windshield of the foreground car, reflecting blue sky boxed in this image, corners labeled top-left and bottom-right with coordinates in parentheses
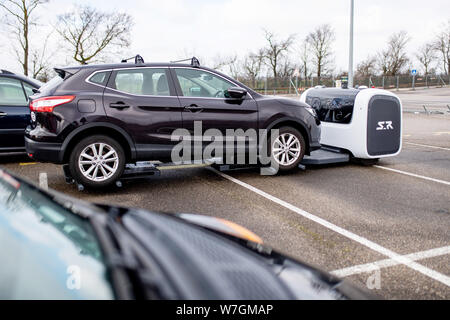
top-left (0, 170), bottom-right (114, 299)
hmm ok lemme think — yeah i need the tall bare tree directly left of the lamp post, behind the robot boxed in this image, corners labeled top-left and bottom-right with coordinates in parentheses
top-left (306, 24), bottom-right (336, 83)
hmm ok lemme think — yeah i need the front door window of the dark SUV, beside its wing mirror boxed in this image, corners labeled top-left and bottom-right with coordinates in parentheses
top-left (175, 68), bottom-right (235, 98)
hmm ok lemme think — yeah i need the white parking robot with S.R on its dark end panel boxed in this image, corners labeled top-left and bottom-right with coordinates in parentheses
top-left (300, 88), bottom-right (402, 164)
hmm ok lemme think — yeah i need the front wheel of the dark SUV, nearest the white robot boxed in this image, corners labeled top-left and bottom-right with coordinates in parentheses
top-left (269, 127), bottom-right (306, 171)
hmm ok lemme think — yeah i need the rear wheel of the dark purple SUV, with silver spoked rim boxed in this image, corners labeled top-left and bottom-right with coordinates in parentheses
top-left (69, 135), bottom-right (125, 188)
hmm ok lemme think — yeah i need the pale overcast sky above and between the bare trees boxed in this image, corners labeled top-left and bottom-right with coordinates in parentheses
top-left (0, 0), bottom-right (450, 75)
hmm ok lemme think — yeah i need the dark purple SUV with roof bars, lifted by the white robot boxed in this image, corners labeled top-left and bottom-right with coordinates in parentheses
top-left (25, 59), bottom-right (320, 187)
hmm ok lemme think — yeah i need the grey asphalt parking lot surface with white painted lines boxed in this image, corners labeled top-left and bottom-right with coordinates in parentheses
top-left (0, 89), bottom-right (450, 299)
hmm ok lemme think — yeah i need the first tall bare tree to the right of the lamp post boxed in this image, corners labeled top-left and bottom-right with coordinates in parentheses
top-left (378, 31), bottom-right (409, 76)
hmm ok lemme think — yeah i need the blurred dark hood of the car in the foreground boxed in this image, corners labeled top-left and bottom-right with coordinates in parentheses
top-left (123, 210), bottom-right (374, 300)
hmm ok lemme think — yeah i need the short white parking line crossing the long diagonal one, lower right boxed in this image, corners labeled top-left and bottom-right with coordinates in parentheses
top-left (331, 246), bottom-right (450, 278)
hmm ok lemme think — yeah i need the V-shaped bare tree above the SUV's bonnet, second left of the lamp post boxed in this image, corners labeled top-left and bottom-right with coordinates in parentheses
top-left (264, 30), bottom-right (295, 81)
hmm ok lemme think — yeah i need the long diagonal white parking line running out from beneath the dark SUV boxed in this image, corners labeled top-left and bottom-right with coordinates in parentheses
top-left (210, 168), bottom-right (450, 287)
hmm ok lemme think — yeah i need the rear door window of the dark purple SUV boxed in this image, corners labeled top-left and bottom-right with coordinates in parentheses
top-left (114, 68), bottom-right (170, 96)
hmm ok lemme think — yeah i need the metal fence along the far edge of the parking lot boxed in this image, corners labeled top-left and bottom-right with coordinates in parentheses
top-left (243, 75), bottom-right (450, 95)
